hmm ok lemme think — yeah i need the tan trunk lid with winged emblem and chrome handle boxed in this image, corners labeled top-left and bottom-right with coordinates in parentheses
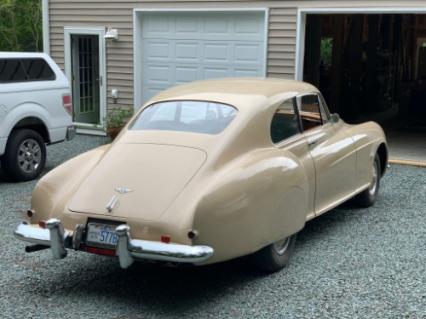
top-left (69, 144), bottom-right (207, 220)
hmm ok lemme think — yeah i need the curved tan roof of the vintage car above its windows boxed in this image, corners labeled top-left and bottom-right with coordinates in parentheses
top-left (148, 78), bottom-right (318, 108)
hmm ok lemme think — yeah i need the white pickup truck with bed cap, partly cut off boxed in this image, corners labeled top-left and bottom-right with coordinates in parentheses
top-left (0, 52), bottom-right (75, 181)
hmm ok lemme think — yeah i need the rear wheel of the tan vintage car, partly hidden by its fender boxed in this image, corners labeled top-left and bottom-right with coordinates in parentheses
top-left (252, 234), bottom-right (296, 272)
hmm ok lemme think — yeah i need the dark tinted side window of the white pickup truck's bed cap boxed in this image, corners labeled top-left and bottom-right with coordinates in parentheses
top-left (0, 58), bottom-right (56, 83)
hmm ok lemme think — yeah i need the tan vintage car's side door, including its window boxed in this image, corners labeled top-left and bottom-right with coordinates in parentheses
top-left (298, 93), bottom-right (356, 215)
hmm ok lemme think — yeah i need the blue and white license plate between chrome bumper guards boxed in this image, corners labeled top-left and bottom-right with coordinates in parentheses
top-left (86, 223), bottom-right (118, 248)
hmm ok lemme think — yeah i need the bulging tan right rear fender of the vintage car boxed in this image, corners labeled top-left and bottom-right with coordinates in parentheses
top-left (193, 149), bottom-right (308, 263)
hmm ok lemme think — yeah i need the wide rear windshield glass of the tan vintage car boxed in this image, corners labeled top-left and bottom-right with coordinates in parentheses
top-left (130, 101), bottom-right (237, 134)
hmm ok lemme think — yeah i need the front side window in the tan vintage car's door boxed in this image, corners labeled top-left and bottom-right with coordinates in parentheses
top-left (299, 94), bottom-right (326, 131)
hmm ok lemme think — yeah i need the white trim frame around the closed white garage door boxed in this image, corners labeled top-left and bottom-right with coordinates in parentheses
top-left (133, 7), bottom-right (269, 110)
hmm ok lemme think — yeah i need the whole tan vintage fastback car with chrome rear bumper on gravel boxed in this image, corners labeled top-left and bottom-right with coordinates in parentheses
top-left (15, 78), bottom-right (388, 271)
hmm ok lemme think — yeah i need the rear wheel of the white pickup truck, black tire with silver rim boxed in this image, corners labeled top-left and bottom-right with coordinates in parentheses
top-left (2, 129), bottom-right (46, 182)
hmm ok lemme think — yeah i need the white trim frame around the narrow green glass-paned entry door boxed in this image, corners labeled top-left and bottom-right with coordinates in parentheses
top-left (64, 27), bottom-right (107, 135)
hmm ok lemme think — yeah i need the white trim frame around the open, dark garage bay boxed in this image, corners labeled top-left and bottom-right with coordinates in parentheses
top-left (294, 6), bottom-right (426, 81)
